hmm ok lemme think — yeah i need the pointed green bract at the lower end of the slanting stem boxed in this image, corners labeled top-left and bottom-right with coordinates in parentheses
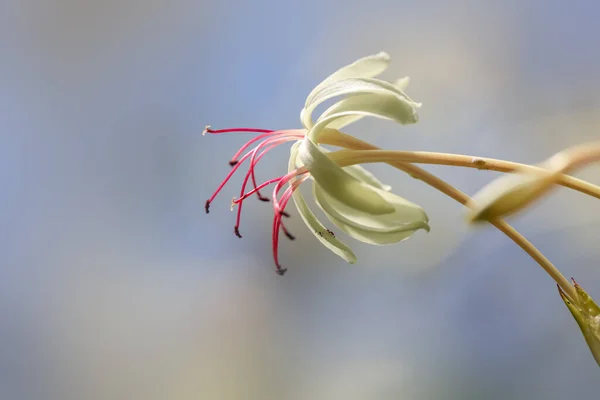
top-left (558, 278), bottom-right (600, 365)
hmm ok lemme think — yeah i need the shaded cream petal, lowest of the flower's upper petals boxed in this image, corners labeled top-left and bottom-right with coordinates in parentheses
top-left (308, 93), bottom-right (419, 142)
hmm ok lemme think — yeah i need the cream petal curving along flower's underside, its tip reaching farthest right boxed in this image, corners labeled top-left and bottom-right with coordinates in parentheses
top-left (313, 183), bottom-right (429, 238)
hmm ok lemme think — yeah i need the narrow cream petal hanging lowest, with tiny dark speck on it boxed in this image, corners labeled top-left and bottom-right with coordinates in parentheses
top-left (288, 142), bottom-right (356, 264)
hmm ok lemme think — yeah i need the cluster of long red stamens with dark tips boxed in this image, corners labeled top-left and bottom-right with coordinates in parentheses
top-left (202, 126), bottom-right (308, 275)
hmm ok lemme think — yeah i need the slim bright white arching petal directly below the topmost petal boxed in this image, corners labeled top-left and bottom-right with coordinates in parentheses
top-left (300, 78), bottom-right (421, 129)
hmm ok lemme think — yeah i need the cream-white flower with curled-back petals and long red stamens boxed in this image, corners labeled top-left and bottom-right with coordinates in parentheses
top-left (204, 52), bottom-right (429, 275)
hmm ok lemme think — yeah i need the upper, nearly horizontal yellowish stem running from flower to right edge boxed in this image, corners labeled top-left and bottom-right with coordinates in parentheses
top-left (320, 129), bottom-right (600, 199)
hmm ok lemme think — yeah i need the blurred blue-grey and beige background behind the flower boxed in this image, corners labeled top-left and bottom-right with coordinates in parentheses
top-left (0, 0), bottom-right (600, 400)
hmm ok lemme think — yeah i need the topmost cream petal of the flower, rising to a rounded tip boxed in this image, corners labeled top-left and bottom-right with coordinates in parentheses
top-left (304, 51), bottom-right (390, 108)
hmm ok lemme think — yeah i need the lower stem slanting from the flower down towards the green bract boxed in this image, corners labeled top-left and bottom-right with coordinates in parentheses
top-left (329, 133), bottom-right (577, 298)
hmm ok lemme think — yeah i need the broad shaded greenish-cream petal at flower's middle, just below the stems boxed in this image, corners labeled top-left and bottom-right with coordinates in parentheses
top-left (298, 137), bottom-right (394, 214)
